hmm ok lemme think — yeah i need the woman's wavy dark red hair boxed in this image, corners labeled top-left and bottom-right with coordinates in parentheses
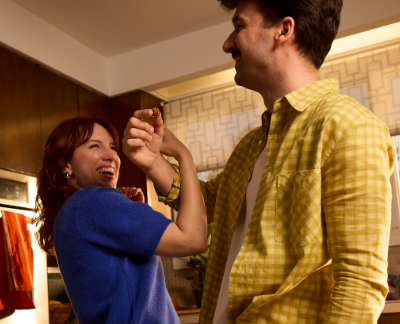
top-left (33, 117), bottom-right (118, 254)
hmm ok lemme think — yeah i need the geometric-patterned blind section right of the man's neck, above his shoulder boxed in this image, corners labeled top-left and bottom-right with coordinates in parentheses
top-left (318, 44), bottom-right (400, 136)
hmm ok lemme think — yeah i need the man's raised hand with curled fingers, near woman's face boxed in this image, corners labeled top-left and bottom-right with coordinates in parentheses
top-left (122, 109), bottom-right (164, 171)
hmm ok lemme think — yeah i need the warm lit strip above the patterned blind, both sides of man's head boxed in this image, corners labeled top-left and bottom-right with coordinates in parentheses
top-left (154, 22), bottom-right (400, 101)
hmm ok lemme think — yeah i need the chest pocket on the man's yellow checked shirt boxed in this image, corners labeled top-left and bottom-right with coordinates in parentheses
top-left (275, 169), bottom-right (322, 247)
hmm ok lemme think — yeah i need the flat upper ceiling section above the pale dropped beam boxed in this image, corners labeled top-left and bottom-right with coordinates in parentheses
top-left (12, 0), bottom-right (231, 57)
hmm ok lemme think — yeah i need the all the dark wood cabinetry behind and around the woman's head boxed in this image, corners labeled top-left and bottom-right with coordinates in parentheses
top-left (0, 41), bottom-right (161, 195)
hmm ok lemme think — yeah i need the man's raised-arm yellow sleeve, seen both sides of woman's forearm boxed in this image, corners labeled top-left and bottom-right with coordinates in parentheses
top-left (154, 164), bottom-right (223, 224)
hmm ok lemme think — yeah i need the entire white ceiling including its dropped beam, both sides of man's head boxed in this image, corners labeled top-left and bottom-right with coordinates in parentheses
top-left (4, 0), bottom-right (400, 96)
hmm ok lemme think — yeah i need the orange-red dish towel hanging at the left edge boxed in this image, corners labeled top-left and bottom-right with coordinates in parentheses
top-left (0, 210), bottom-right (35, 310)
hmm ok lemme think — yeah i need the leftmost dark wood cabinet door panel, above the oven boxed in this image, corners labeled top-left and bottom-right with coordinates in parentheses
top-left (0, 47), bottom-right (42, 175)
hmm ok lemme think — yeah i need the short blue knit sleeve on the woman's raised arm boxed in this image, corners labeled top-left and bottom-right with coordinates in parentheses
top-left (75, 187), bottom-right (172, 256)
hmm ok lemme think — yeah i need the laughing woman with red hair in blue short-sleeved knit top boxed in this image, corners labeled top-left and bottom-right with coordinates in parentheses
top-left (35, 117), bottom-right (207, 324)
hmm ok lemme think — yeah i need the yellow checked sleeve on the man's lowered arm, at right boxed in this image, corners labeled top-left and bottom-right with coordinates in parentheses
top-left (322, 118), bottom-right (395, 324)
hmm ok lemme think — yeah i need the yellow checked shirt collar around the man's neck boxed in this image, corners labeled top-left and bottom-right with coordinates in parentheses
top-left (280, 79), bottom-right (339, 112)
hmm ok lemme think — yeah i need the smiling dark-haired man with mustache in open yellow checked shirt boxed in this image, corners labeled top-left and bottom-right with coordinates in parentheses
top-left (123, 0), bottom-right (395, 324)
